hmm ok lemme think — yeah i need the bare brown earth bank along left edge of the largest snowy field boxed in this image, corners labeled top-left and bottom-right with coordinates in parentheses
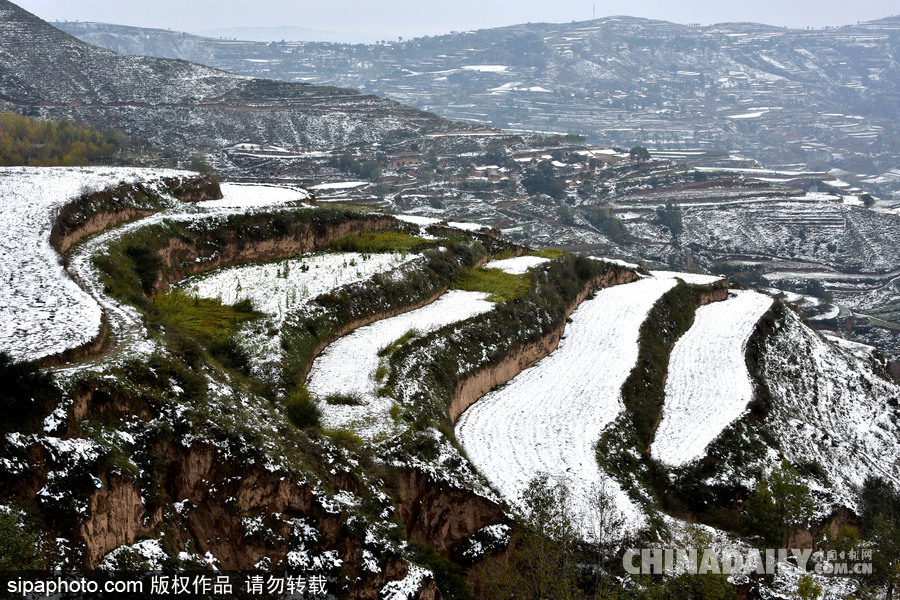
top-left (450, 269), bottom-right (640, 422)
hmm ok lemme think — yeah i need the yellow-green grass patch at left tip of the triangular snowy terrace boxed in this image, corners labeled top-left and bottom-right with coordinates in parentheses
top-left (153, 289), bottom-right (261, 342)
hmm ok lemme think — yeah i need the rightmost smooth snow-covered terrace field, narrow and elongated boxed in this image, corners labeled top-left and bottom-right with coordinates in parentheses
top-left (651, 291), bottom-right (772, 467)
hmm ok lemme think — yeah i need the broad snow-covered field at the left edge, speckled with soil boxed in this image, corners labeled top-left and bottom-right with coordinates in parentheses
top-left (0, 167), bottom-right (185, 360)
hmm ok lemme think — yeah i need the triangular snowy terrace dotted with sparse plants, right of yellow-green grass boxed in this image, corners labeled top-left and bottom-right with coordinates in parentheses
top-left (180, 252), bottom-right (420, 317)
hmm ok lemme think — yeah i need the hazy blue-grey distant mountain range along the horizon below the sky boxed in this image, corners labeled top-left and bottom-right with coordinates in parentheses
top-left (60, 12), bottom-right (900, 194)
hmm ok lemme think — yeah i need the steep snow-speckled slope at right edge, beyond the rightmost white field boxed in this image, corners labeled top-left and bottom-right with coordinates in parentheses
top-left (761, 310), bottom-right (900, 508)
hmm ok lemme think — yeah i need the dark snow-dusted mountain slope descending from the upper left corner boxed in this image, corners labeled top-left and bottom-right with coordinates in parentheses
top-left (0, 0), bottom-right (460, 170)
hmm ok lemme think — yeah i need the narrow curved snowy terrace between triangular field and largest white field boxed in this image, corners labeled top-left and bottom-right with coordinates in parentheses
top-left (307, 290), bottom-right (494, 439)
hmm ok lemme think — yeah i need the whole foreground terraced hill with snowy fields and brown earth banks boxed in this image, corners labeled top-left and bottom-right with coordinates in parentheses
top-left (0, 168), bottom-right (900, 598)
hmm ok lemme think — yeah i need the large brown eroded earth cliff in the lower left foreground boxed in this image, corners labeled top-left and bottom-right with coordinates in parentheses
top-left (77, 436), bottom-right (426, 600)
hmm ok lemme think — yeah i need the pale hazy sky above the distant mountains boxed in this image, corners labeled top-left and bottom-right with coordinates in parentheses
top-left (13, 0), bottom-right (900, 38)
